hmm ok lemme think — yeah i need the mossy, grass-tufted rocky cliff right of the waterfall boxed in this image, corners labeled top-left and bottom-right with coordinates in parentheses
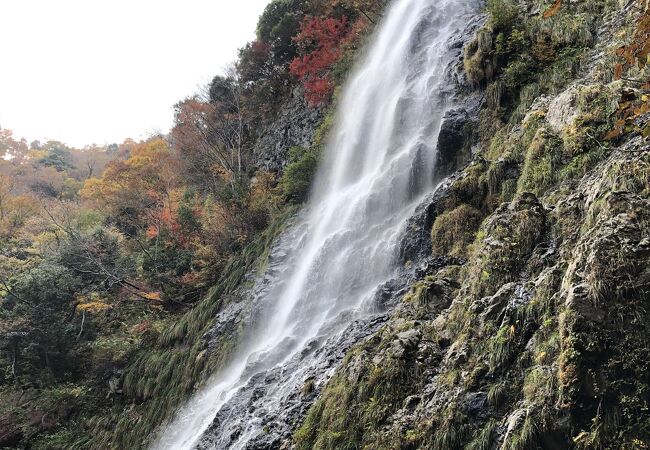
top-left (288, 0), bottom-right (650, 449)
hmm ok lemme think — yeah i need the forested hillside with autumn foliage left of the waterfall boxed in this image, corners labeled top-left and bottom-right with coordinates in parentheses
top-left (0, 0), bottom-right (381, 449)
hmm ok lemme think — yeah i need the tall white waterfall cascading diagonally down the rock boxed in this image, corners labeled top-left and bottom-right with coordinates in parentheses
top-left (154, 0), bottom-right (479, 450)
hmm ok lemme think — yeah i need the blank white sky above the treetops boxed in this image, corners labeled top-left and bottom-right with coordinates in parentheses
top-left (0, 0), bottom-right (270, 147)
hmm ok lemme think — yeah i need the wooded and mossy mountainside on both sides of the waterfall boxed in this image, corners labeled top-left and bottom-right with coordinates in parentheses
top-left (0, 0), bottom-right (650, 450)
